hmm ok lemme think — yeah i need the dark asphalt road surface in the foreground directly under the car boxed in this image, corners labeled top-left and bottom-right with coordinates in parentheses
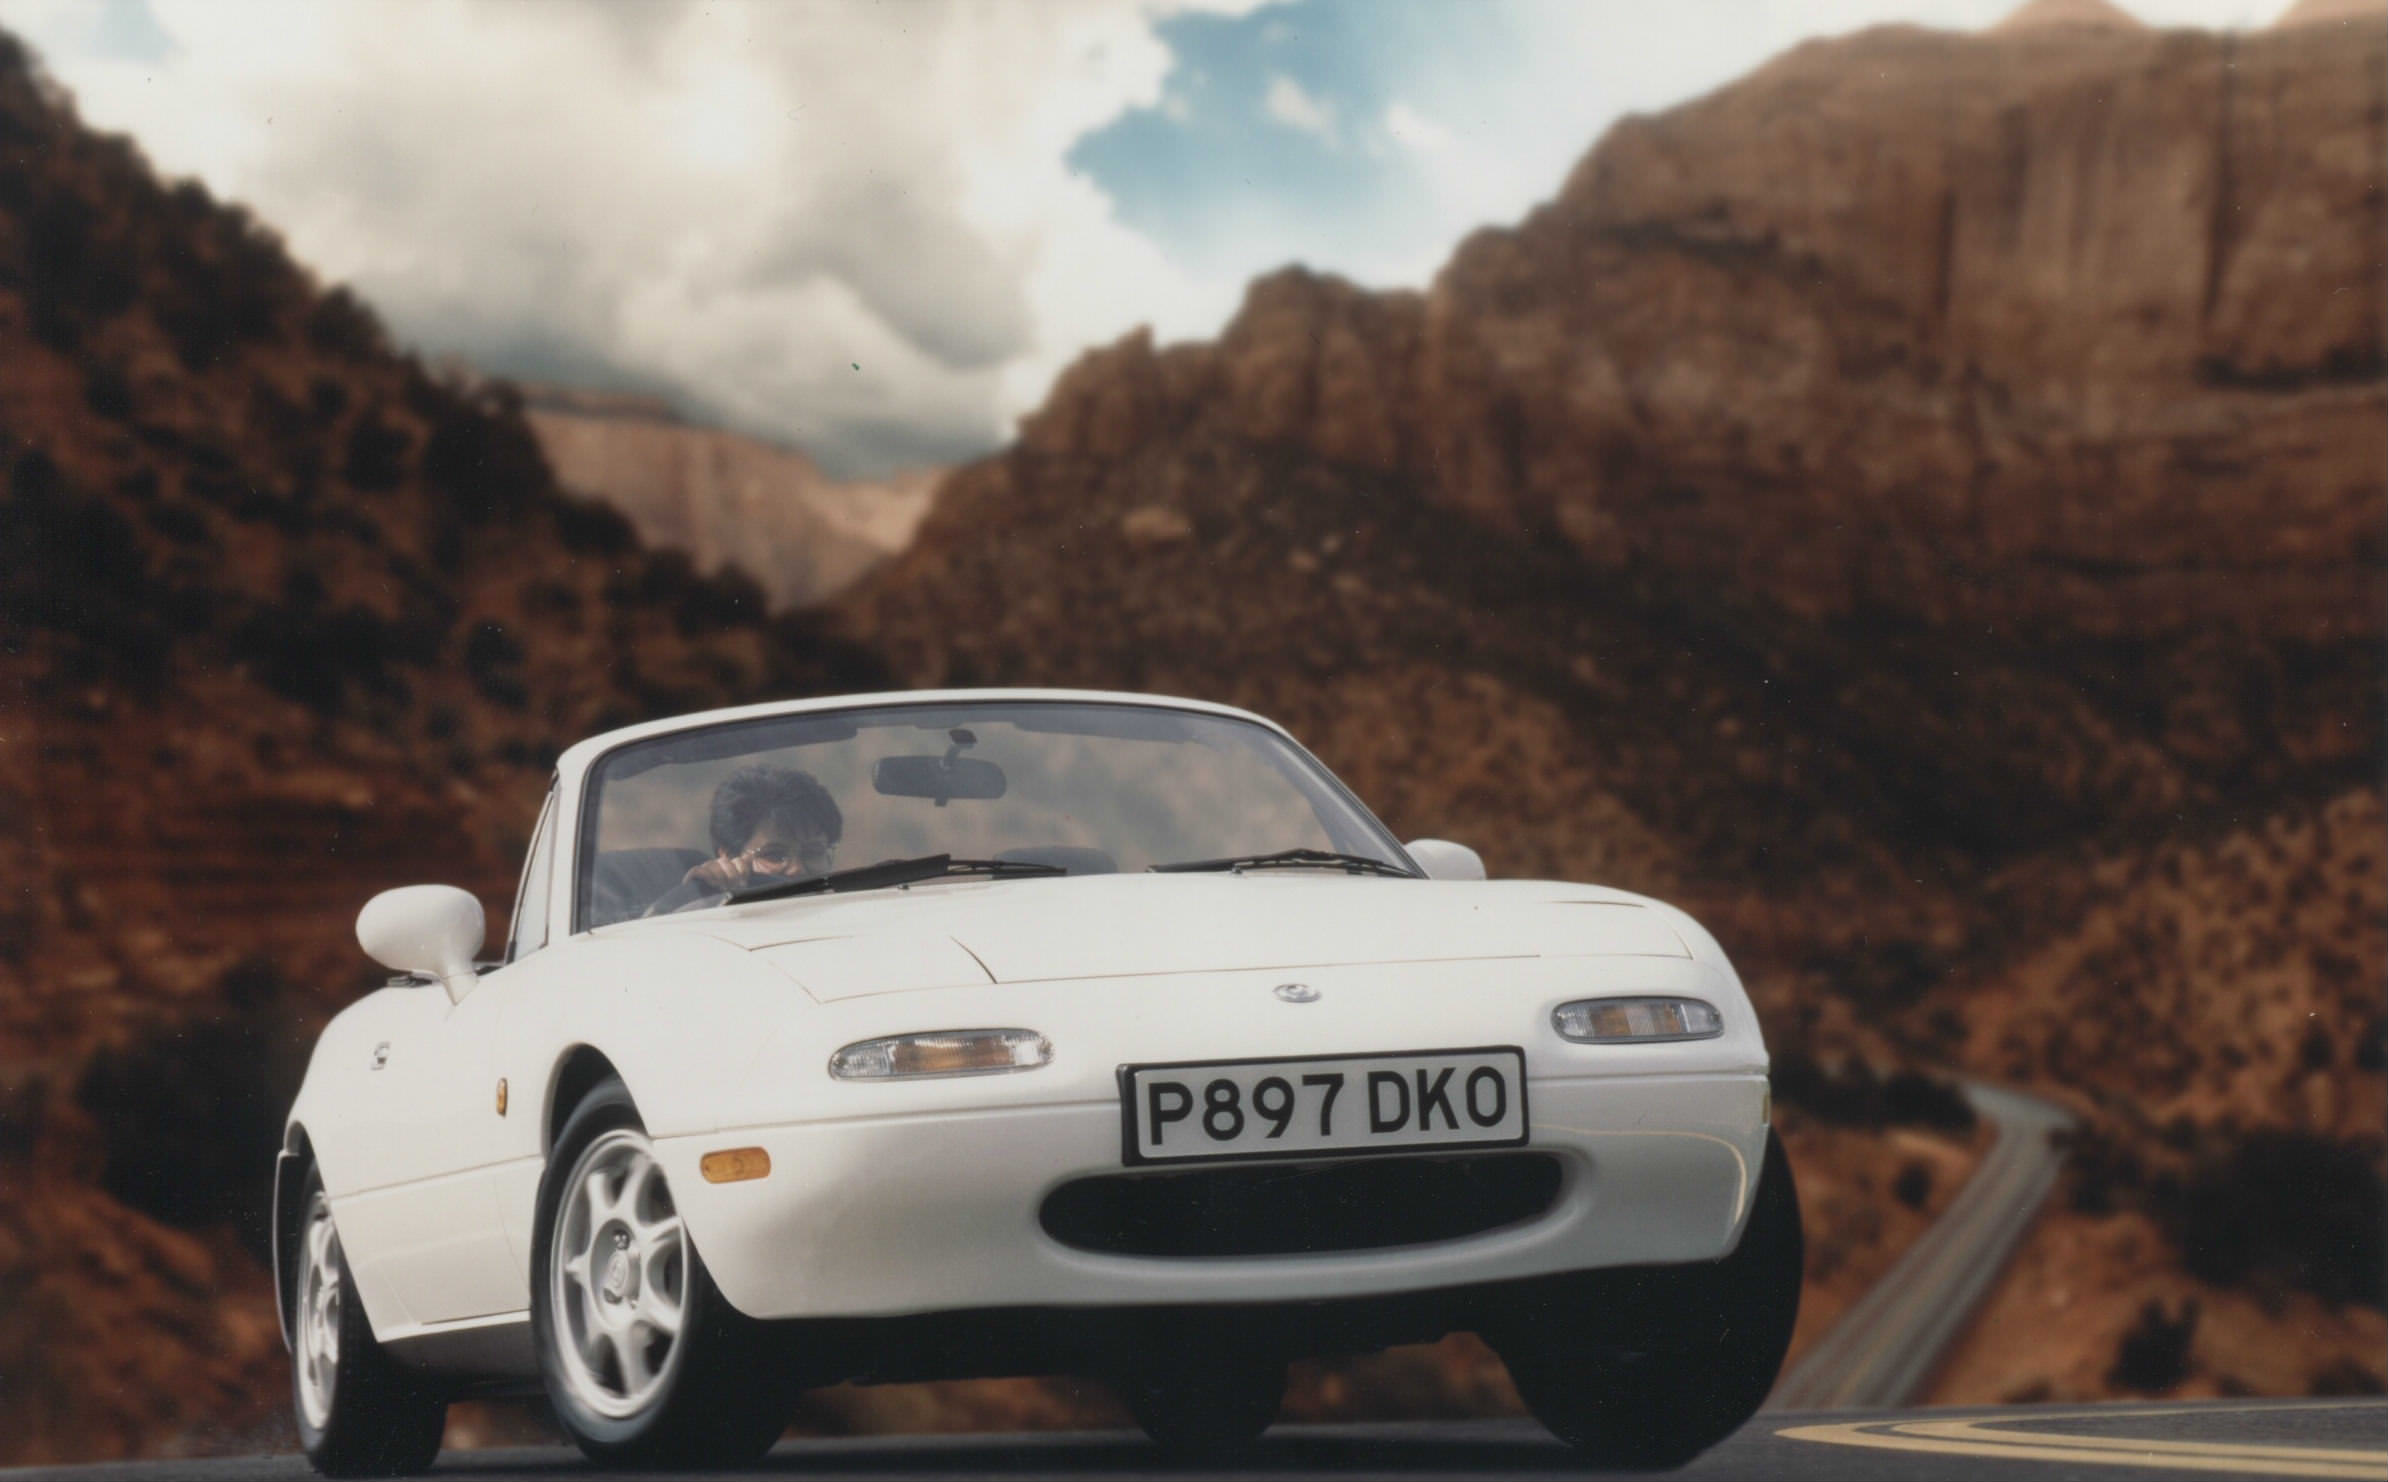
top-left (0, 1401), bottom-right (2388, 1482)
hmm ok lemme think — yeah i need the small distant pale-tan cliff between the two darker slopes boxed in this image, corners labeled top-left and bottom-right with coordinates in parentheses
top-left (528, 387), bottom-right (943, 606)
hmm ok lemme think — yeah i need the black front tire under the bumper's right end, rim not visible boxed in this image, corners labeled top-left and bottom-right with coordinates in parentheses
top-left (1490, 1131), bottom-right (1805, 1470)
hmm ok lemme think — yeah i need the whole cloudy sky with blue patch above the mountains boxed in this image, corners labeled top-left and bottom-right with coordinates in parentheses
top-left (0, 0), bottom-right (2288, 475)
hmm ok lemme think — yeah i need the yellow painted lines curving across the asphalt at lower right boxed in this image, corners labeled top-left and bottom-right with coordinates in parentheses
top-left (1774, 1406), bottom-right (2388, 1482)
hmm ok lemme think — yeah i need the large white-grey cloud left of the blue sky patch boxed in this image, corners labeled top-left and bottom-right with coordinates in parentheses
top-left (0, 0), bottom-right (1270, 468)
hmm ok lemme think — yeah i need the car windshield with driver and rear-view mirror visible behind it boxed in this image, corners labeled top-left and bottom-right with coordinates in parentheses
top-left (576, 702), bottom-right (1409, 928)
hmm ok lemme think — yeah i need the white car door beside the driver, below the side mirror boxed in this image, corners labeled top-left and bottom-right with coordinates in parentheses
top-left (339, 797), bottom-right (554, 1336)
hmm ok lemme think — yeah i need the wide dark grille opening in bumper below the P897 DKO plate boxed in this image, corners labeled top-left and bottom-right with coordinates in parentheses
top-left (1039, 1153), bottom-right (1559, 1255)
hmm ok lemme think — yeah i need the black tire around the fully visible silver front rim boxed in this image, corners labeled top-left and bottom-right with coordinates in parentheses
top-left (530, 1079), bottom-right (793, 1468)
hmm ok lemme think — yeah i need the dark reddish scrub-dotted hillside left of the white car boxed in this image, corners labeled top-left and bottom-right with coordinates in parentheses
top-left (0, 36), bottom-right (876, 1463)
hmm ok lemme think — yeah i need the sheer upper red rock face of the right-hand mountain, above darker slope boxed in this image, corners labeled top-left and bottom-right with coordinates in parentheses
top-left (1022, 26), bottom-right (2388, 640)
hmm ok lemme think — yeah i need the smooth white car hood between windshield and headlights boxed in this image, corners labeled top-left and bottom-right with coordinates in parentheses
top-left (607, 871), bottom-right (1691, 1000)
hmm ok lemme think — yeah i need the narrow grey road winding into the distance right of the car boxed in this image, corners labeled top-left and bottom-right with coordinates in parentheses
top-left (1767, 1086), bottom-right (2073, 1410)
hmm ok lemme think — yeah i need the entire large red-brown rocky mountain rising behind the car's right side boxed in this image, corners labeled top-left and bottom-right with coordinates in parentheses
top-left (843, 14), bottom-right (2388, 1398)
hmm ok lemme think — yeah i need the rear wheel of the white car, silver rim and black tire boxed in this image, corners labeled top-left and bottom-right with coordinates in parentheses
top-left (289, 1169), bottom-right (447, 1477)
